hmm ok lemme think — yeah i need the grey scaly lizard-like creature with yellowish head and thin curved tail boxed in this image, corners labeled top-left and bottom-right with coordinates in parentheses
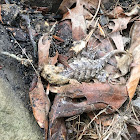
top-left (42, 50), bottom-right (126, 84)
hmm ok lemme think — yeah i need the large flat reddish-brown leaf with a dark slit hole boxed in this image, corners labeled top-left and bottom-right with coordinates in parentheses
top-left (50, 83), bottom-right (127, 120)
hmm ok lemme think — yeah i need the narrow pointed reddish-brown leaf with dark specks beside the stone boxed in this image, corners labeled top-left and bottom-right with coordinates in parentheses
top-left (29, 78), bottom-right (50, 128)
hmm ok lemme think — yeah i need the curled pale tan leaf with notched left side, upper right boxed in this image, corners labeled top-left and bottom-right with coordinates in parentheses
top-left (109, 17), bottom-right (131, 32)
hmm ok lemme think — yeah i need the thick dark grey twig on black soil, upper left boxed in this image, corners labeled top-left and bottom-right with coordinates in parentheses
top-left (21, 14), bottom-right (37, 57)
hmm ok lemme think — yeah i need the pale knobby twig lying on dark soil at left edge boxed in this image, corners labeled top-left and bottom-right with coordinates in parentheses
top-left (1, 52), bottom-right (32, 66)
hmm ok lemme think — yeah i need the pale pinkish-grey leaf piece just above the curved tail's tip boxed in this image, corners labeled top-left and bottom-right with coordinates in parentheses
top-left (110, 32), bottom-right (124, 51)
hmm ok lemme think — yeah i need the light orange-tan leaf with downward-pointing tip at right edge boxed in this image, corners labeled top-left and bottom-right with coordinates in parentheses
top-left (126, 45), bottom-right (140, 100)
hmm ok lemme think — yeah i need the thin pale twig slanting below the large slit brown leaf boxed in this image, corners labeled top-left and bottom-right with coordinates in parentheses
top-left (78, 108), bottom-right (106, 140)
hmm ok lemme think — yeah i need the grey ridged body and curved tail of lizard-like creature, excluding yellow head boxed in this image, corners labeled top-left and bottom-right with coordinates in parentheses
top-left (61, 50), bottom-right (126, 82)
